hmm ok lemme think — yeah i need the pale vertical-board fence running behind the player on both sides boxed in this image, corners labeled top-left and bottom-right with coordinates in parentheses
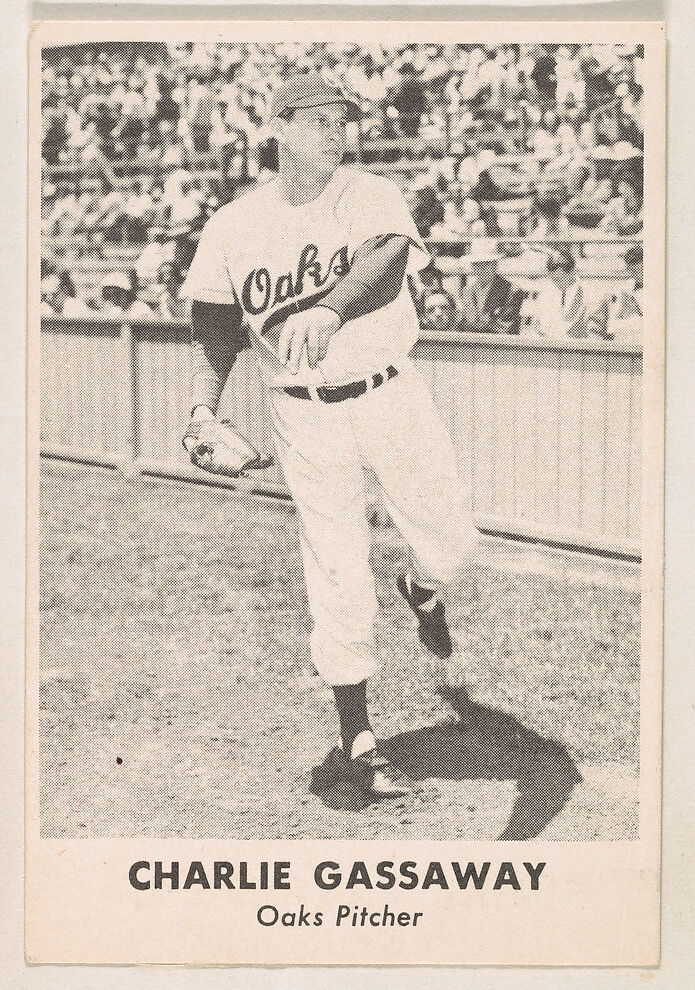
top-left (41, 318), bottom-right (642, 557)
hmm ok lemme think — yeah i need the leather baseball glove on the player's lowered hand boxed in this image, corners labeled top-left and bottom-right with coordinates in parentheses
top-left (183, 419), bottom-right (273, 478)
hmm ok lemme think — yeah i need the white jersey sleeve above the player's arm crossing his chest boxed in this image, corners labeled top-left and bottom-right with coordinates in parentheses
top-left (339, 176), bottom-right (432, 275)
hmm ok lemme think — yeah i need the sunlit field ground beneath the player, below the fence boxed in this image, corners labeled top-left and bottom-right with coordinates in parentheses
top-left (38, 463), bottom-right (639, 840)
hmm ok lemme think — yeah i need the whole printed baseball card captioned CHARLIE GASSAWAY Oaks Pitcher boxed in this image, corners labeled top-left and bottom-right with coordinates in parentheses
top-left (25, 19), bottom-right (665, 967)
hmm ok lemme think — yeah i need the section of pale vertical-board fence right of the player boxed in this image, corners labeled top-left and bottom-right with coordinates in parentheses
top-left (414, 334), bottom-right (641, 555)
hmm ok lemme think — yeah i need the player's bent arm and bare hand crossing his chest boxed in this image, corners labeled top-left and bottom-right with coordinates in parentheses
top-left (278, 234), bottom-right (410, 374)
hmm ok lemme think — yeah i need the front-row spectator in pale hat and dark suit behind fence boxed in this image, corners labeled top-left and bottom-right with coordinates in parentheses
top-left (460, 239), bottom-right (524, 333)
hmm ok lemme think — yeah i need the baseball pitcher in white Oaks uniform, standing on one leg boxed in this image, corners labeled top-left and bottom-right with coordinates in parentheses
top-left (182, 73), bottom-right (475, 797)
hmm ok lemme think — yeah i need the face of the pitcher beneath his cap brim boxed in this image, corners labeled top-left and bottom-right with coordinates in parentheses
top-left (282, 103), bottom-right (347, 175)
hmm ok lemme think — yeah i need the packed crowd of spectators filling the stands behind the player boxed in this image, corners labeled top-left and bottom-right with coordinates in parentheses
top-left (42, 43), bottom-right (643, 333)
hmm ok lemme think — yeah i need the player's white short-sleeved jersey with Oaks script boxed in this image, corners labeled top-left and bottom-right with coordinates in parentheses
top-left (181, 166), bottom-right (430, 386)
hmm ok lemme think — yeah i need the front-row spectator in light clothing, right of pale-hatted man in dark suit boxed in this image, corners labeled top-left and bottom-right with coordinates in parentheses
top-left (533, 247), bottom-right (609, 338)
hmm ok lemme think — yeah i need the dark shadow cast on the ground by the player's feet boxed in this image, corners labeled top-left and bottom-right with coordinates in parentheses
top-left (311, 687), bottom-right (582, 839)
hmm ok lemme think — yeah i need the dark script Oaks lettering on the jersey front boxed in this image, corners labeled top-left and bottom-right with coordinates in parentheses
top-left (241, 244), bottom-right (350, 346)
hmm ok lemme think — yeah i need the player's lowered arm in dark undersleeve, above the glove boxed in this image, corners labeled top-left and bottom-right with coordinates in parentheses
top-left (191, 299), bottom-right (246, 419)
